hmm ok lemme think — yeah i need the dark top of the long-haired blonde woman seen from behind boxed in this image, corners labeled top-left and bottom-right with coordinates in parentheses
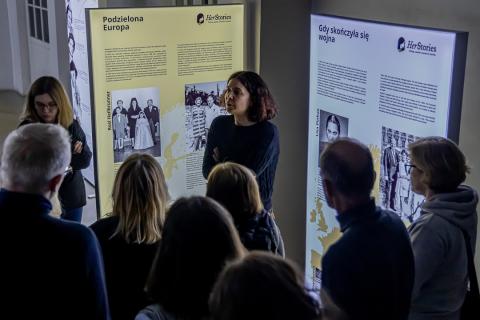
top-left (90, 217), bottom-right (158, 320)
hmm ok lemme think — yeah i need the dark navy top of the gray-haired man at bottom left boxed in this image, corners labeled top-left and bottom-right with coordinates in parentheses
top-left (0, 189), bottom-right (110, 320)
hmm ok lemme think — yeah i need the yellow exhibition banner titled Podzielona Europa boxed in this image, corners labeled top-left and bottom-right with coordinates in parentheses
top-left (87, 5), bottom-right (244, 216)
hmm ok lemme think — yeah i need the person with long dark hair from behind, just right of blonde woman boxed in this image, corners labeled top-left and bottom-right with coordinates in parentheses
top-left (135, 197), bottom-right (245, 320)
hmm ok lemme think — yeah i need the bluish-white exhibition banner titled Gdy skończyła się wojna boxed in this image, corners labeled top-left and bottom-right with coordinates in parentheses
top-left (305, 15), bottom-right (468, 289)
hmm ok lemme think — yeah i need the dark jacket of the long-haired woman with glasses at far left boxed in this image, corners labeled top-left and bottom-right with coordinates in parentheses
top-left (19, 120), bottom-right (92, 209)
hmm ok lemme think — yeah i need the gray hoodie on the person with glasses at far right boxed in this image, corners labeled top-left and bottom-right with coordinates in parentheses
top-left (408, 185), bottom-right (478, 320)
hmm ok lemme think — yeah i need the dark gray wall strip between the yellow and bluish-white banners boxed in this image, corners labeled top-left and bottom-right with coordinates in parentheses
top-left (260, 0), bottom-right (311, 267)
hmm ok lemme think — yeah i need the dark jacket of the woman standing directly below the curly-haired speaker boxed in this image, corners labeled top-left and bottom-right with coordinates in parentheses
top-left (236, 210), bottom-right (285, 257)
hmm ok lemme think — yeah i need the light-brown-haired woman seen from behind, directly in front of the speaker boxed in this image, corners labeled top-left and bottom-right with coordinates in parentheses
top-left (206, 162), bottom-right (285, 256)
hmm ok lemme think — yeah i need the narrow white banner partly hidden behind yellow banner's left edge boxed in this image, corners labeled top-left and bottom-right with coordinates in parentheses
top-left (65, 0), bottom-right (99, 184)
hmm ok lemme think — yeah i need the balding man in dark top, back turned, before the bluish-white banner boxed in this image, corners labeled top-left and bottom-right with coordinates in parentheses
top-left (320, 138), bottom-right (414, 320)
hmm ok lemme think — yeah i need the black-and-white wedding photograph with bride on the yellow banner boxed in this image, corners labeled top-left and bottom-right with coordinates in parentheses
top-left (111, 87), bottom-right (161, 163)
